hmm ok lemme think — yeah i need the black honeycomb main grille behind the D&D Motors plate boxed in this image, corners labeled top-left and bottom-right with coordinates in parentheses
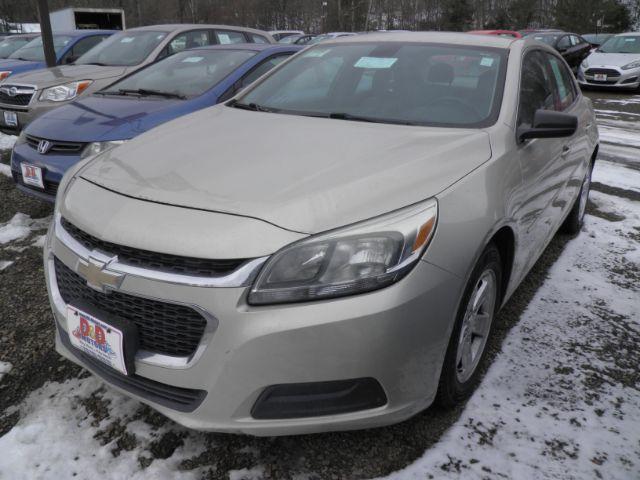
top-left (54, 258), bottom-right (207, 357)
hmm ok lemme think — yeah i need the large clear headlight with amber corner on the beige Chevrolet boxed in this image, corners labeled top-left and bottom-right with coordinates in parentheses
top-left (248, 199), bottom-right (438, 305)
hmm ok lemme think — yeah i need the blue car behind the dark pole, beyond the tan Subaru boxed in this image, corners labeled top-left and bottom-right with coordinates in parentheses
top-left (0, 30), bottom-right (114, 81)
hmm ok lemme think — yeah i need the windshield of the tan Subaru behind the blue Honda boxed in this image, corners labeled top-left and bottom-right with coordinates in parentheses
top-left (75, 30), bottom-right (167, 66)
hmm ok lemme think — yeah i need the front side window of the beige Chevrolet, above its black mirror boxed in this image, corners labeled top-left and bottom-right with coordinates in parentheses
top-left (517, 50), bottom-right (555, 126)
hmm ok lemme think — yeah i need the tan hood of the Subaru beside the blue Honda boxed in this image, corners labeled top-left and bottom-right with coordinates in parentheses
top-left (11, 65), bottom-right (127, 90)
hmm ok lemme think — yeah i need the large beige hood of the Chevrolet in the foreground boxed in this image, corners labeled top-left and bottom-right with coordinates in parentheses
top-left (81, 105), bottom-right (491, 233)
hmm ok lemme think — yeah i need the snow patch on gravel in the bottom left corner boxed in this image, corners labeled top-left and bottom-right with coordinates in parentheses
top-left (0, 377), bottom-right (201, 480)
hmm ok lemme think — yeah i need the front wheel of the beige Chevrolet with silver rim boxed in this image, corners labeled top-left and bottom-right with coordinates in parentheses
top-left (436, 244), bottom-right (502, 408)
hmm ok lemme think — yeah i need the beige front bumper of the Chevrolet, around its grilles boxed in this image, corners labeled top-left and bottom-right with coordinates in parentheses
top-left (44, 214), bottom-right (461, 436)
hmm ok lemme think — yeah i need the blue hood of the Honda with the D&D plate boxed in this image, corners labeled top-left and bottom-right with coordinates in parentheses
top-left (26, 95), bottom-right (190, 142)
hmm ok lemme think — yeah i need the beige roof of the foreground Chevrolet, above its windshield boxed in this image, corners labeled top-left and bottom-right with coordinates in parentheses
top-left (322, 32), bottom-right (518, 48)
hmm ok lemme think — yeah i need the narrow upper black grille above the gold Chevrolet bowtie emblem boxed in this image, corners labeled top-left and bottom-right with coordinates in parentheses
top-left (62, 218), bottom-right (245, 277)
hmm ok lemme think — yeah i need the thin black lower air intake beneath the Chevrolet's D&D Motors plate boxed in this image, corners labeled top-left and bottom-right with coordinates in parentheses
top-left (58, 327), bottom-right (207, 412)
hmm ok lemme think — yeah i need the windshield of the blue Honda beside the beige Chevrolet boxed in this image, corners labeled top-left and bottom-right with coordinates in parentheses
top-left (105, 50), bottom-right (257, 97)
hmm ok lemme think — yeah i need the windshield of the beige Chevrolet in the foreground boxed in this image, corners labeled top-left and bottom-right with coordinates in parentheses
top-left (234, 42), bottom-right (507, 127)
